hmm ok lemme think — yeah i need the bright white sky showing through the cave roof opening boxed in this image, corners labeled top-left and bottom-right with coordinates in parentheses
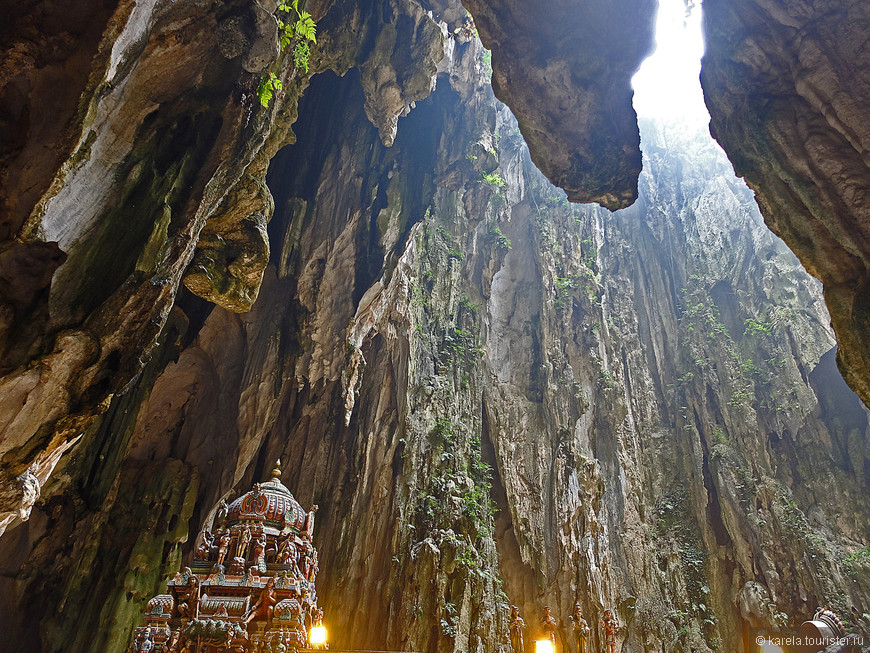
top-left (632, 0), bottom-right (710, 124)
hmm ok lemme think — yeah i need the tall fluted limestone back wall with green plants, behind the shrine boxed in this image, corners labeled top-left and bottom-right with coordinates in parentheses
top-left (0, 1), bottom-right (870, 652)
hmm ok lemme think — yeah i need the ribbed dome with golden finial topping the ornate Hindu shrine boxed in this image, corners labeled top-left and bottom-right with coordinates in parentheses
top-left (220, 461), bottom-right (307, 534)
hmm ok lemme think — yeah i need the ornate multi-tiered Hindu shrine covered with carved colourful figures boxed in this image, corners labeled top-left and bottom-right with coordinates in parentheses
top-left (128, 461), bottom-right (325, 653)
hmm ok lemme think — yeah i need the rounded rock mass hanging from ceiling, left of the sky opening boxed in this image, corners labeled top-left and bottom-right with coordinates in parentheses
top-left (463, 0), bottom-right (656, 210)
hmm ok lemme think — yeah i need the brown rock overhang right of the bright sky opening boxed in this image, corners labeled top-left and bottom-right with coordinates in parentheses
top-left (701, 0), bottom-right (870, 402)
